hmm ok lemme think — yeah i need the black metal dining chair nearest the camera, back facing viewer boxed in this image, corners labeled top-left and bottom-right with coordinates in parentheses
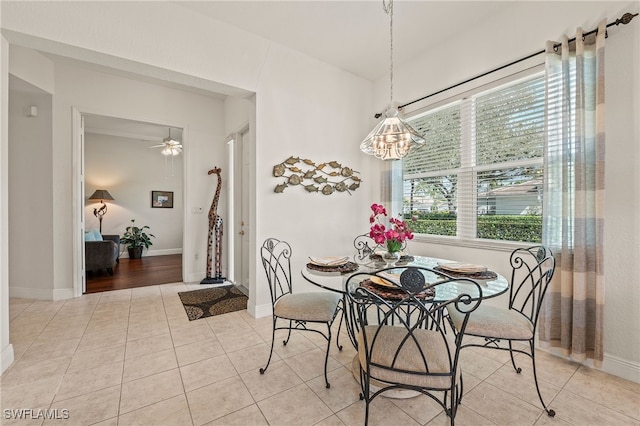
top-left (347, 267), bottom-right (482, 425)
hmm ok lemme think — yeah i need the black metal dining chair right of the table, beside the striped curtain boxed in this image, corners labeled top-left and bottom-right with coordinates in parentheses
top-left (449, 246), bottom-right (556, 417)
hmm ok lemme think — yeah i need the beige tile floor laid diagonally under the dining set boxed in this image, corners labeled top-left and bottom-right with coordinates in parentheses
top-left (0, 283), bottom-right (640, 426)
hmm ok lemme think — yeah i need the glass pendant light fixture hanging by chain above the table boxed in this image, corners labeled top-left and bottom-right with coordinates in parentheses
top-left (360, 0), bottom-right (425, 160)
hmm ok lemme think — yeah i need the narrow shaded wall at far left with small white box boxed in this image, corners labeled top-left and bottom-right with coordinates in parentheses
top-left (9, 75), bottom-right (54, 299)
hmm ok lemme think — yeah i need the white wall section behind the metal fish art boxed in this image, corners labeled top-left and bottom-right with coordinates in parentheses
top-left (255, 43), bottom-right (380, 312)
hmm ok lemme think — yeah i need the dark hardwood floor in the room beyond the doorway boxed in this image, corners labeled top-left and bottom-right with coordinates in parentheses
top-left (86, 254), bottom-right (182, 293)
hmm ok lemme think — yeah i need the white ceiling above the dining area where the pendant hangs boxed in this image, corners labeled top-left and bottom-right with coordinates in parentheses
top-left (175, 0), bottom-right (510, 81)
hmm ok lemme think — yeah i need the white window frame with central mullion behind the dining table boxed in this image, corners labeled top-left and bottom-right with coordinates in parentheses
top-left (398, 63), bottom-right (544, 251)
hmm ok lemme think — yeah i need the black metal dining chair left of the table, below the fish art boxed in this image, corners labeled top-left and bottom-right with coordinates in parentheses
top-left (260, 238), bottom-right (342, 388)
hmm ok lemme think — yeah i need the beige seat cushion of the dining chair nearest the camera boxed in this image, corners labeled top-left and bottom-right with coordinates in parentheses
top-left (358, 325), bottom-right (455, 389)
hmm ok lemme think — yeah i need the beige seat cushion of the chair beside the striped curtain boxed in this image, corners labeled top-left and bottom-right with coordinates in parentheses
top-left (449, 304), bottom-right (533, 340)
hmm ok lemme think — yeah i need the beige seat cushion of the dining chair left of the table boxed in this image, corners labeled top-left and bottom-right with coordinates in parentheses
top-left (273, 292), bottom-right (340, 322)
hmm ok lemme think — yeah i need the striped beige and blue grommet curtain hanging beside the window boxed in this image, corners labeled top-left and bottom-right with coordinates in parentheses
top-left (539, 19), bottom-right (606, 367)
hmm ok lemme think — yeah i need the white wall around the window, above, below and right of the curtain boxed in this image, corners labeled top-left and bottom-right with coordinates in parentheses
top-left (374, 1), bottom-right (640, 382)
